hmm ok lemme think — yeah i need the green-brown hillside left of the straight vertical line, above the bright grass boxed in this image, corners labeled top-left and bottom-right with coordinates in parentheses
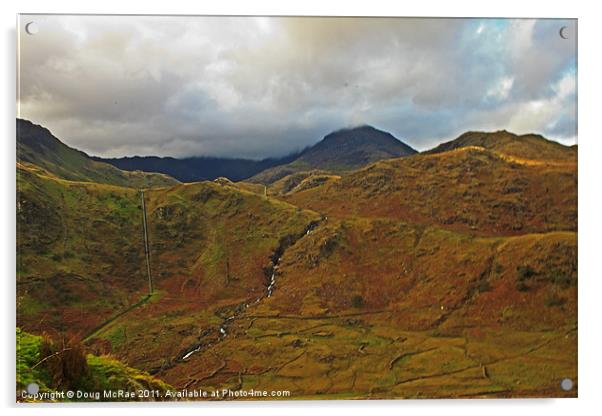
top-left (17, 166), bottom-right (146, 334)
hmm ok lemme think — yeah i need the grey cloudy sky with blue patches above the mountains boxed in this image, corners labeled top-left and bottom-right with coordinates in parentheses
top-left (18, 16), bottom-right (577, 158)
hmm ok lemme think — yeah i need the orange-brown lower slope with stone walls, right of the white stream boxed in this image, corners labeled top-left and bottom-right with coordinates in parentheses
top-left (161, 218), bottom-right (577, 399)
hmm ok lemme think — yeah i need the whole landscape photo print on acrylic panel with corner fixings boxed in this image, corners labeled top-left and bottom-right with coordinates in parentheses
top-left (16, 14), bottom-right (578, 402)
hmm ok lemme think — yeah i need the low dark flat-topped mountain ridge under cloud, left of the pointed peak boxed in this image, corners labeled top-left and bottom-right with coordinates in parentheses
top-left (94, 153), bottom-right (299, 182)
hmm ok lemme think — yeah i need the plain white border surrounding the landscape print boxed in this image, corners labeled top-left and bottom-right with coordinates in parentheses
top-left (0, 0), bottom-right (602, 416)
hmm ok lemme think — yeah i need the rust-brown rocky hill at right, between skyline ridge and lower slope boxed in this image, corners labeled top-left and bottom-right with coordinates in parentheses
top-left (282, 147), bottom-right (577, 235)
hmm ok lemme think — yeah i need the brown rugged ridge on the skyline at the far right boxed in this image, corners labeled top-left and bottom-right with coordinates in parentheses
top-left (424, 130), bottom-right (577, 160)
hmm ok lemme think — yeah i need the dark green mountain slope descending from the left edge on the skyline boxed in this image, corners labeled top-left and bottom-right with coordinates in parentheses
top-left (17, 119), bottom-right (178, 188)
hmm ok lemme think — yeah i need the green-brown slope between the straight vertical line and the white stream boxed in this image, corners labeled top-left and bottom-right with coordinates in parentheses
top-left (82, 182), bottom-right (320, 372)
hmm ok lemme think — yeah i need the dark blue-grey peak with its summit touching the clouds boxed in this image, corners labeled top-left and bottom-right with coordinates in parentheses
top-left (251, 126), bottom-right (418, 183)
